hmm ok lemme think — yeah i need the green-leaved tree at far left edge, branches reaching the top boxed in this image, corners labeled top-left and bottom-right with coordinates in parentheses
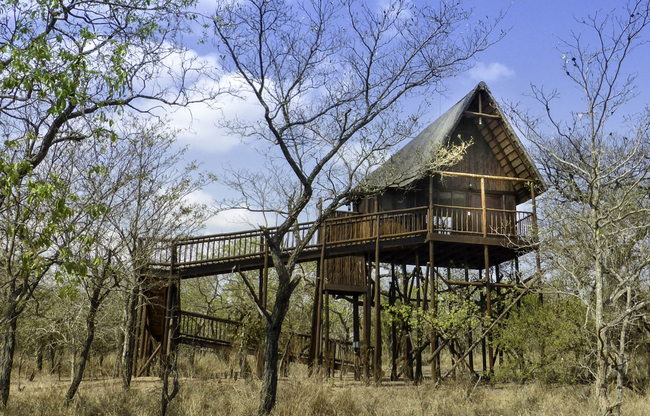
top-left (0, 0), bottom-right (206, 406)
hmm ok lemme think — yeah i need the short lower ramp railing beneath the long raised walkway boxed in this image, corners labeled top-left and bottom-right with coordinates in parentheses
top-left (178, 311), bottom-right (241, 345)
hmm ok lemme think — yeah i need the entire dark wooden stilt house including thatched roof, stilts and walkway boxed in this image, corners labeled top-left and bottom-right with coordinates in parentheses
top-left (134, 83), bottom-right (545, 379)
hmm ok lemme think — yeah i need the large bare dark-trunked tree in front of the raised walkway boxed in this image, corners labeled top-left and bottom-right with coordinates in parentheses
top-left (211, 0), bottom-right (499, 414)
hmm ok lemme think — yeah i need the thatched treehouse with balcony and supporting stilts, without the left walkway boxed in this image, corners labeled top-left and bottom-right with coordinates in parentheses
top-left (311, 83), bottom-right (545, 380)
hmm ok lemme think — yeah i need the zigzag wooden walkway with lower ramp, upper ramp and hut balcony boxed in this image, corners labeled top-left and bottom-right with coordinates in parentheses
top-left (136, 205), bottom-right (536, 372)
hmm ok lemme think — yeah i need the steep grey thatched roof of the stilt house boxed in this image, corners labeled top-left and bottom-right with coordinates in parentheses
top-left (362, 82), bottom-right (546, 200)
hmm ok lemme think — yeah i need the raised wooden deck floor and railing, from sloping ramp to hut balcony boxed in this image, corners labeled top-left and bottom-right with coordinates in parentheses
top-left (149, 205), bottom-right (534, 278)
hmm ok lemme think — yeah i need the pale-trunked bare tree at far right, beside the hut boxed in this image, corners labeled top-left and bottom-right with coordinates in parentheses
top-left (508, 0), bottom-right (650, 415)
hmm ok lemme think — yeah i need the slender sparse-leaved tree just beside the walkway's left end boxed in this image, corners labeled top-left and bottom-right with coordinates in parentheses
top-left (97, 120), bottom-right (215, 389)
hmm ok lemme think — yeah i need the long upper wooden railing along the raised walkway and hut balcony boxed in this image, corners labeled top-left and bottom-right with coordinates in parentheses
top-left (150, 205), bottom-right (533, 267)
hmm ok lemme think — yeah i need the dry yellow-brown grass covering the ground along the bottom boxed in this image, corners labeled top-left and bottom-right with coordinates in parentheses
top-left (0, 360), bottom-right (650, 416)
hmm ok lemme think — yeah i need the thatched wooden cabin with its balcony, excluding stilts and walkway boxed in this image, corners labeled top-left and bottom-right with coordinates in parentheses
top-left (354, 83), bottom-right (545, 269)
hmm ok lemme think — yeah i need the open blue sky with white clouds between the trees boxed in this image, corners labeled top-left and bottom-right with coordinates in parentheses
top-left (171, 0), bottom-right (650, 233)
